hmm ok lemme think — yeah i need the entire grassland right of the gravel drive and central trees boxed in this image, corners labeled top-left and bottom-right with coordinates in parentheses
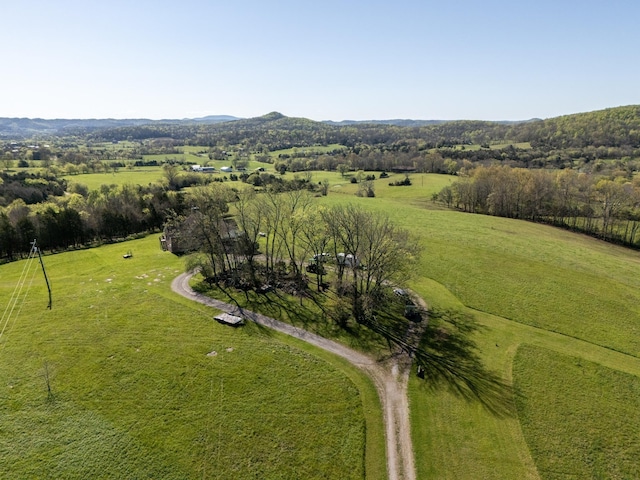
top-left (326, 176), bottom-right (640, 479)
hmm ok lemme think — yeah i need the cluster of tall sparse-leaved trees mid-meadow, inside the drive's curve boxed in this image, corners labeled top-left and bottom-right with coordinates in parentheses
top-left (180, 185), bottom-right (419, 323)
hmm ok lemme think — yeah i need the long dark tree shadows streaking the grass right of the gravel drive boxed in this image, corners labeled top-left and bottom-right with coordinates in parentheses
top-left (414, 310), bottom-right (516, 417)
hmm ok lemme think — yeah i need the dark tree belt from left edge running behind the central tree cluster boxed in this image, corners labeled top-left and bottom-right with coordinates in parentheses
top-left (0, 163), bottom-right (328, 261)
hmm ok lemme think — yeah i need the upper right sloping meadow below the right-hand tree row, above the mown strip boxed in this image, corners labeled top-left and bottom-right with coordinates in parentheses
top-left (323, 179), bottom-right (640, 356)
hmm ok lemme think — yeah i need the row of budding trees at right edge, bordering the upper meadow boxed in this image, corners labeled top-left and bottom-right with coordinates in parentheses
top-left (434, 165), bottom-right (640, 248)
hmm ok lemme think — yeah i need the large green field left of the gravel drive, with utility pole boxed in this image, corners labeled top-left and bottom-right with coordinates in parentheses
top-left (0, 236), bottom-right (385, 479)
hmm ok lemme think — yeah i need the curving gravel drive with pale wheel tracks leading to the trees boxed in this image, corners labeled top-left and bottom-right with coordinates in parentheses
top-left (171, 273), bottom-right (416, 480)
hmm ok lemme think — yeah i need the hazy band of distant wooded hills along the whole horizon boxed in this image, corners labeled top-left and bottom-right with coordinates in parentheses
top-left (0, 105), bottom-right (640, 153)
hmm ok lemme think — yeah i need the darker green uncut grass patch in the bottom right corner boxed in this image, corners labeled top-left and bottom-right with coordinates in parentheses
top-left (514, 345), bottom-right (640, 480)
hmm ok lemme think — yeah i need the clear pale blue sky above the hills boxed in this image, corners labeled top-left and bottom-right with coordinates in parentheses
top-left (0, 0), bottom-right (640, 120)
